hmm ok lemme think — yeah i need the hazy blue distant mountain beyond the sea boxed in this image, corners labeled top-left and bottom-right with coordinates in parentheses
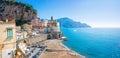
top-left (57, 17), bottom-right (91, 28)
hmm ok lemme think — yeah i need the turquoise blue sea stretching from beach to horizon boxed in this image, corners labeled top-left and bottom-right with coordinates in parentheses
top-left (61, 28), bottom-right (120, 58)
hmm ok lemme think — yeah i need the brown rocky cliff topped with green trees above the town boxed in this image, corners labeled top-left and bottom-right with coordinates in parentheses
top-left (0, 0), bottom-right (37, 25)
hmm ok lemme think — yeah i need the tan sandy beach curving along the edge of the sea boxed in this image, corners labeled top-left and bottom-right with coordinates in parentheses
top-left (39, 39), bottom-right (85, 58)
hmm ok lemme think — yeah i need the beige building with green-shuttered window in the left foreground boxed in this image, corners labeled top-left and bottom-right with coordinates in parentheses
top-left (0, 19), bottom-right (16, 58)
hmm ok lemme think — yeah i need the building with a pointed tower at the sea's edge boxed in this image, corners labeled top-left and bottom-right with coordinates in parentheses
top-left (47, 16), bottom-right (62, 39)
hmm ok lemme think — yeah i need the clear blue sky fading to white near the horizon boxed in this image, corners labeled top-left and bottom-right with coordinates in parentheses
top-left (17, 0), bottom-right (120, 28)
